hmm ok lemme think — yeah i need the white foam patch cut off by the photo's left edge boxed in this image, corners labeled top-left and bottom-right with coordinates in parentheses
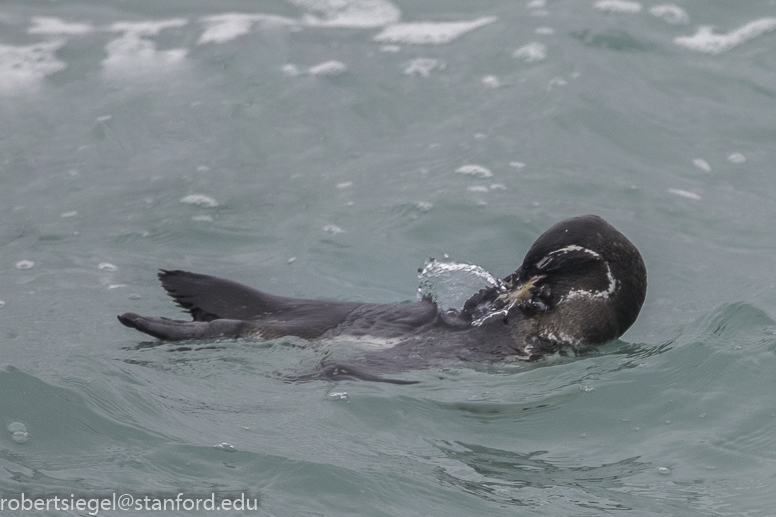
top-left (0, 40), bottom-right (67, 93)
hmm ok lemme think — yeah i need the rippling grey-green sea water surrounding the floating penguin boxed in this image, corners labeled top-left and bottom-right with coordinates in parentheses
top-left (0, 0), bottom-right (776, 517)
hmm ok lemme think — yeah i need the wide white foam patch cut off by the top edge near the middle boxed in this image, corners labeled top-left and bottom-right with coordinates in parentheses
top-left (289, 0), bottom-right (401, 29)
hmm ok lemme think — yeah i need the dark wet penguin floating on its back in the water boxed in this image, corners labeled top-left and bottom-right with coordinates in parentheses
top-left (118, 215), bottom-right (647, 382)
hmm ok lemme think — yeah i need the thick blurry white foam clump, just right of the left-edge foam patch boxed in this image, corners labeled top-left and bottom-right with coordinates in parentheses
top-left (102, 18), bottom-right (188, 79)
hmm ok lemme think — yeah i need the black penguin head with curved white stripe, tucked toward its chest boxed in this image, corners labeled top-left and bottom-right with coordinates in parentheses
top-left (504, 215), bottom-right (647, 345)
